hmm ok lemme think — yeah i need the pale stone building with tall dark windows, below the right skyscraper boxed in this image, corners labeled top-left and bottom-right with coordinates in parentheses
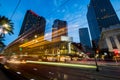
top-left (99, 25), bottom-right (120, 53)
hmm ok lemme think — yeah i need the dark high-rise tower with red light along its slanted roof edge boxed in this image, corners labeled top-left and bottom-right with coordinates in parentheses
top-left (19, 10), bottom-right (46, 37)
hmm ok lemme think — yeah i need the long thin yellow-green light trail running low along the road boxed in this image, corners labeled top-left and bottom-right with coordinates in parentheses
top-left (26, 61), bottom-right (96, 68)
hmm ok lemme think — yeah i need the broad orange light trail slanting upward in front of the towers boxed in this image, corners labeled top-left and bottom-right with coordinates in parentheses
top-left (19, 28), bottom-right (66, 48)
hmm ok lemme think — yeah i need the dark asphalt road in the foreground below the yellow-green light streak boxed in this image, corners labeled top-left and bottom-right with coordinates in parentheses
top-left (7, 63), bottom-right (120, 80)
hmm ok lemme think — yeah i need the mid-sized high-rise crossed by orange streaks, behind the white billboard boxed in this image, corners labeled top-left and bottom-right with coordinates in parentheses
top-left (52, 19), bottom-right (68, 40)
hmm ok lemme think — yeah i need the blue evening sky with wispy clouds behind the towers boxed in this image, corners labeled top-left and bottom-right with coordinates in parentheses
top-left (0, 0), bottom-right (120, 45)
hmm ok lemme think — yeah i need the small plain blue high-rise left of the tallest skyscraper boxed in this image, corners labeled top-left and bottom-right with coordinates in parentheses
top-left (79, 28), bottom-right (91, 47)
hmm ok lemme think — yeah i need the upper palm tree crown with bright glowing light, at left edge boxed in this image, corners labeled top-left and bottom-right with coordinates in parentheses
top-left (0, 16), bottom-right (14, 37)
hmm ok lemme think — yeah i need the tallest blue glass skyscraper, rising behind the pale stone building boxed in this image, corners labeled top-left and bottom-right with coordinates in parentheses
top-left (87, 0), bottom-right (120, 41)
